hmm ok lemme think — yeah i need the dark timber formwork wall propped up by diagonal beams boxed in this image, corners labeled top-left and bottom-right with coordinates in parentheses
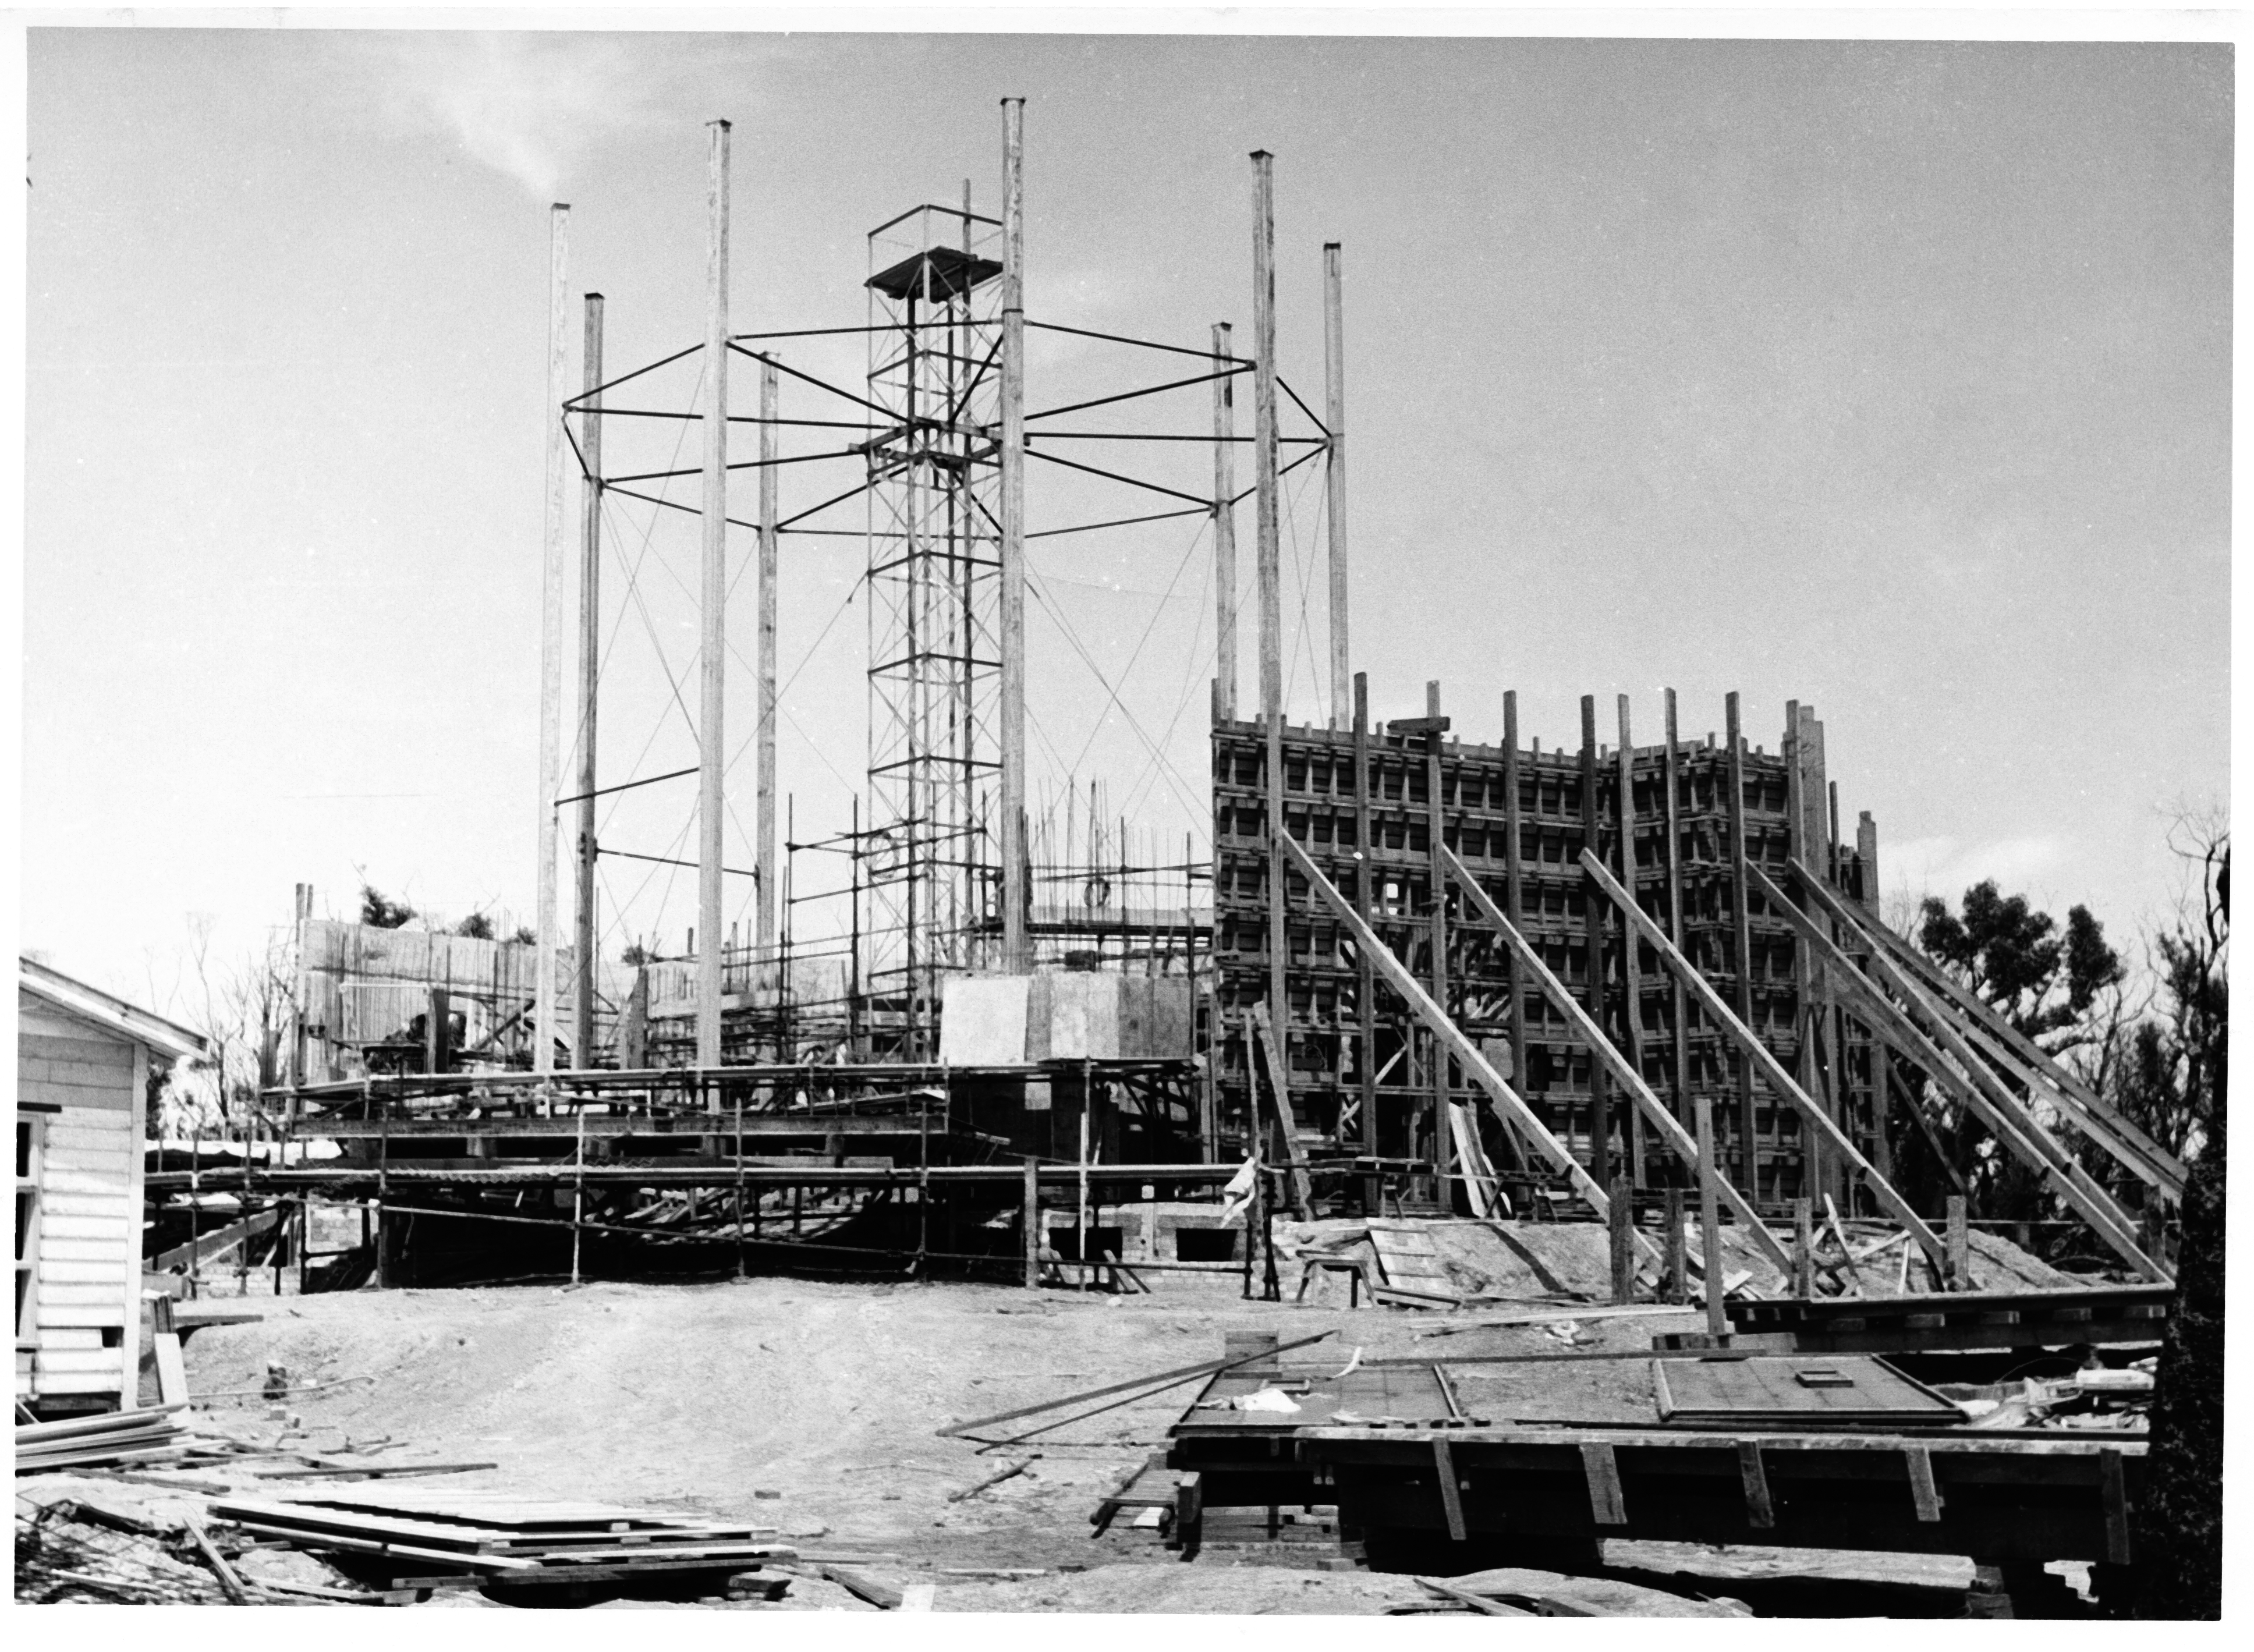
top-left (1210, 721), bottom-right (1882, 1201)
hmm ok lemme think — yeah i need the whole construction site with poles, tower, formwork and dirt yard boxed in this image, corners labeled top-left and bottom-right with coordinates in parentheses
top-left (16, 84), bottom-right (2189, 1618)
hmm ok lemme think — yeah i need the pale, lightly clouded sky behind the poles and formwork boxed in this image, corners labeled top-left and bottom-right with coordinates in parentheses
top-left (23, 29), bottom-right (2231, 1008)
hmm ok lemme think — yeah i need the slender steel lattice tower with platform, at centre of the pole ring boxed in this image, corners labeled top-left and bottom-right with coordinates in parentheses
top-left (861, 189), bottom-right (1003, 1059)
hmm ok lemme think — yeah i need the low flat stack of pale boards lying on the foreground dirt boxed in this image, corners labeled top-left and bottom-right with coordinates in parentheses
top-left (212, 1490), bottom-right (798, 1591)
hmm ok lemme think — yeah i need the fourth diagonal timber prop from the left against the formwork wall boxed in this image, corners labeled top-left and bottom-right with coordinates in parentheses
top-left (1747, 861), bottom-right (2171, 1285)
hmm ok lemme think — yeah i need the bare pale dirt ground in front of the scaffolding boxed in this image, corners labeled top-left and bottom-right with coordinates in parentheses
top-left (158, 1275), bottom-right (1776, 1611)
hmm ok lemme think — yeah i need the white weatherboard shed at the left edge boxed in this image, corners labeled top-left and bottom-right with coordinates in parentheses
top-left (16, 958), bottom-right (207, 1413)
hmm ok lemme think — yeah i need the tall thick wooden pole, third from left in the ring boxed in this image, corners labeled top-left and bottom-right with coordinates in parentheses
top-left (696, 119), bottom-right (728, 1066)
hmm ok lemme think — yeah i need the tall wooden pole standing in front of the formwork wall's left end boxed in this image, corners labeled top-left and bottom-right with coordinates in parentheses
top-left (1253, 149), bottom-right (1292, 1147)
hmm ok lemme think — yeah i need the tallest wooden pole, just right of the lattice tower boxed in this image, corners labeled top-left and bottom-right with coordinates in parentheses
top-left (998, 97), bottom-right (1032, 974)
